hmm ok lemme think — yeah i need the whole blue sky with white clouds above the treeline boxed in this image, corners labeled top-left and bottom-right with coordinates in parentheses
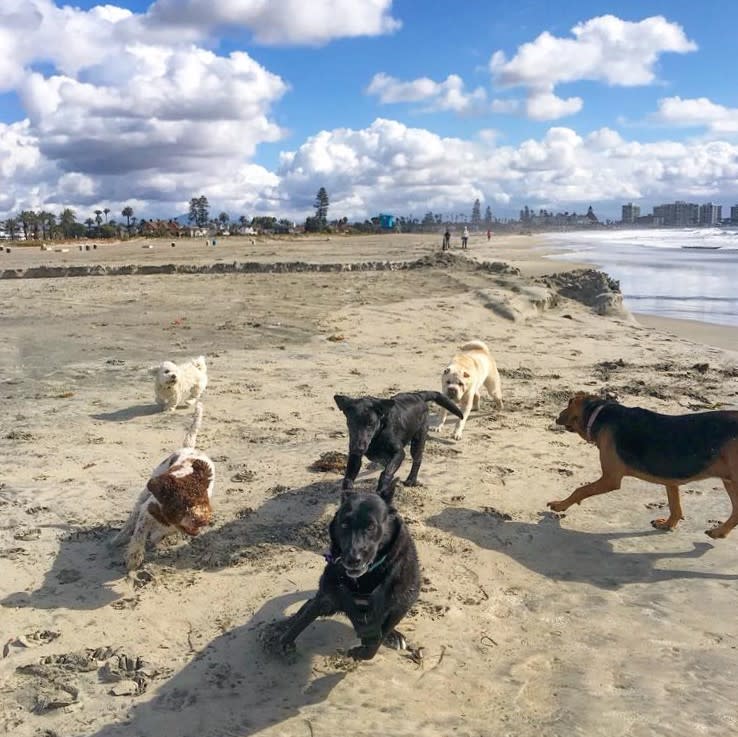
top-left (0, 0), bottom-right (738, 223)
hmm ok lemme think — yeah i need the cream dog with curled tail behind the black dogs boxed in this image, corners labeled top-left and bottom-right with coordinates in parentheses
top-left (433, 340), bottom-right (502, 440)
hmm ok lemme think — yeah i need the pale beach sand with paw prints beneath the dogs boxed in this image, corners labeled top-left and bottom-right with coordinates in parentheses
top-left (0, 236), bottom-right (738, 737)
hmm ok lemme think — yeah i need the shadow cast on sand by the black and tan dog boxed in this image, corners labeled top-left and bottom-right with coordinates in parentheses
top-left (427, 507), bottom-right (738, 589)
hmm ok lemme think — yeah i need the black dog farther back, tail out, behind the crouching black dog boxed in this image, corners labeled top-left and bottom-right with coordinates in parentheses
top-left (333, 391), bottom-right (463, 494)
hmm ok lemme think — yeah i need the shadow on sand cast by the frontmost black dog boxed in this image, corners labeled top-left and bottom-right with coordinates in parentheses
top-left (82, 593), bottom-right (355, 737)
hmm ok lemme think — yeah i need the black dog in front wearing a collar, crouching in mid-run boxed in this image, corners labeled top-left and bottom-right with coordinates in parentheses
top-left (279, 491), bottom-right (420, 660)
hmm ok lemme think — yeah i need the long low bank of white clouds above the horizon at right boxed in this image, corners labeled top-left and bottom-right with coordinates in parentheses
top-left (278, 118), bottom-right (738, 217)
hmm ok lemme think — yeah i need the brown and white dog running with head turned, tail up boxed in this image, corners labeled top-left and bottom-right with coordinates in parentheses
top-left (113, 402), bottom-right (215, 571)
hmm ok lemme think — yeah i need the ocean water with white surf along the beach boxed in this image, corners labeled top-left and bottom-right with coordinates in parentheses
top-left (546, 228), bottom-right (738, 326)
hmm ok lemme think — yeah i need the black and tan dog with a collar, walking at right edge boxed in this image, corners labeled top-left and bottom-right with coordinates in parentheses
top-left (548, 392), bottom-right (738, 538)
